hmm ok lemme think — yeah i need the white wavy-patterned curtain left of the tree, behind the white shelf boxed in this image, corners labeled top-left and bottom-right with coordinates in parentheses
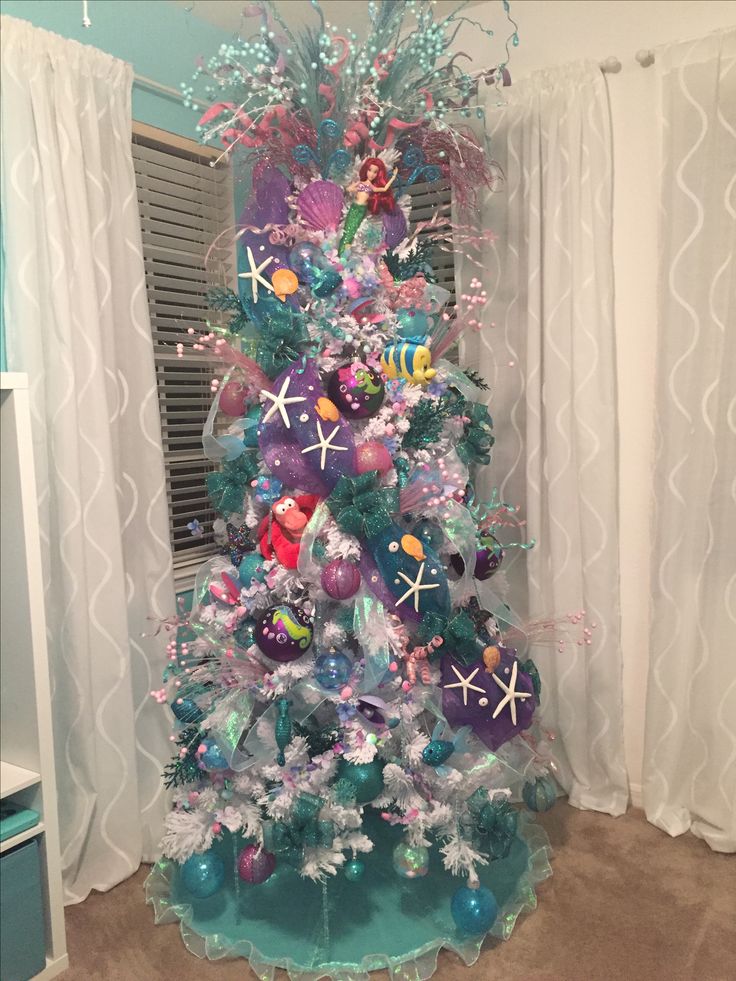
top-left (2, 17), bottom-right (174, 902)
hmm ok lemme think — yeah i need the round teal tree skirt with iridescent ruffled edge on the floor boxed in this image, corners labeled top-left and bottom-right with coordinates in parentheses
top-left (146, 811), bottom-right (551, 981)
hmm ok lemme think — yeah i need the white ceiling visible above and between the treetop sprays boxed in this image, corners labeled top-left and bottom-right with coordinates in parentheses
top-left (170, 0), bottom-right (490, 34)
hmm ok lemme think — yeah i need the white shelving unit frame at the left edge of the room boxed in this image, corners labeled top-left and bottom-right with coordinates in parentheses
top-left (0, 373), bottom-right (69, 981)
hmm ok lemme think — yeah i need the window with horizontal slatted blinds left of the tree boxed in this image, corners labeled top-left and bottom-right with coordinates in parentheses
top-left (133, 123), bottom-right (235, 591)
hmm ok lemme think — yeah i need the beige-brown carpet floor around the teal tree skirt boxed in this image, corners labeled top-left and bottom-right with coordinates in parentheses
top-left (63, 803), bottom-right (736, 981)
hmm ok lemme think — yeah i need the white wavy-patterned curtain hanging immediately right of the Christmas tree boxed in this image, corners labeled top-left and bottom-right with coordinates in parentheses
top-left (463, 62), bottom-right (628, 814)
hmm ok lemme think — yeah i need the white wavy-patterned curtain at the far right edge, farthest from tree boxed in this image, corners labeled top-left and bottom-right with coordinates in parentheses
top-left (644, 30), bottom-right (736, 852)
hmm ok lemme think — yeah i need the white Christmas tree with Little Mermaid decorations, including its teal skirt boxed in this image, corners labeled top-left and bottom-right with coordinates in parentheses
top-left (148, 0), bottom-right (568, 979)
